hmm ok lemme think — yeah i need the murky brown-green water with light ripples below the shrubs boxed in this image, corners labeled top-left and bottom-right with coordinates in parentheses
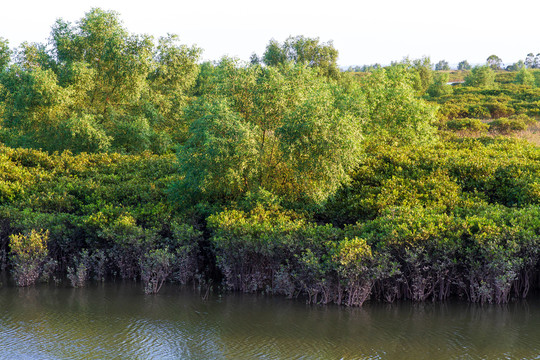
top-left (0, 274), bottom-right (540, 359)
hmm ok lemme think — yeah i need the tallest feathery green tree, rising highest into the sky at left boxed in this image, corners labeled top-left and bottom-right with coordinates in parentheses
top-left (51, 8), bottom-right (153, 116)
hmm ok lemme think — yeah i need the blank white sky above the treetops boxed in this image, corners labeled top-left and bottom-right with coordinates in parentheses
top-left (0, 0), bottom-right (540, 66)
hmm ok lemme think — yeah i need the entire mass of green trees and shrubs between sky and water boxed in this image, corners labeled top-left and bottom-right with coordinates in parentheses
top-left (0, 9), bottom-right (540, 306)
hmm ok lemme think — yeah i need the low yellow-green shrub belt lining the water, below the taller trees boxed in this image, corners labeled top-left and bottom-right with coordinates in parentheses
top-left (0, 132), bottom-right (540, 306)
